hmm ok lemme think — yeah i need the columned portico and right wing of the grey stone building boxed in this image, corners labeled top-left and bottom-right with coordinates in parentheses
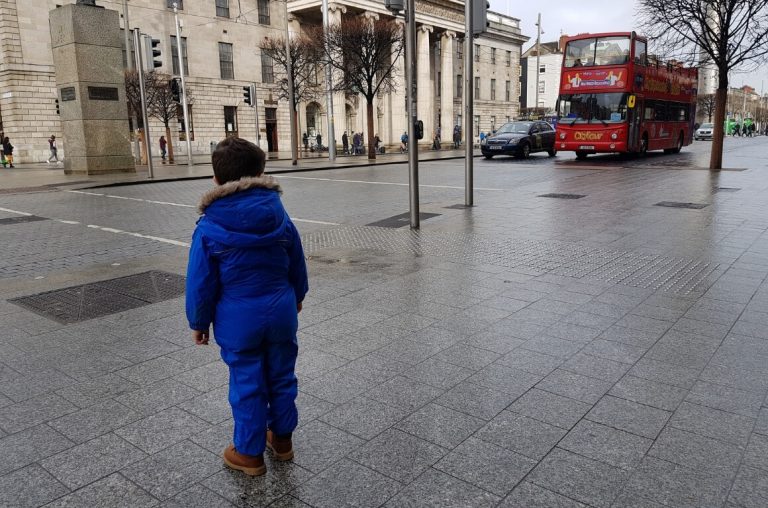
top-left (288, 0), bottom-right (528, 145)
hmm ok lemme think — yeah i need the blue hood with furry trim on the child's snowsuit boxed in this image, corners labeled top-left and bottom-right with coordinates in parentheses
top-left (197, 176), bottom-right (290, 248)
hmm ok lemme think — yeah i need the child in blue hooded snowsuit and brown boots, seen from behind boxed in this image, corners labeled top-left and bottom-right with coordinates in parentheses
top-left (186, 137), bottom-right (308, 476)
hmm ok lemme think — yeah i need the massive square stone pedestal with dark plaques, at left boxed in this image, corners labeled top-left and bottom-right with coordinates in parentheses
top-left (49, 3), bottom-right (136, 175)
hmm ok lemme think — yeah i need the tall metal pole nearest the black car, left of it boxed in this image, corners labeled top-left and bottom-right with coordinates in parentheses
top-left (464, 0), bottom-right (472, 206)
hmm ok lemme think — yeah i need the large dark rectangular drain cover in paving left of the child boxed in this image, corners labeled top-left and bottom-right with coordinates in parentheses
top-left (8, 271), bottom-right (184, 324)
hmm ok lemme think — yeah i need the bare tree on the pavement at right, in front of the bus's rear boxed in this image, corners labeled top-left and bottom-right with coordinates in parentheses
top-left (639, 0), bottom-right (768, 170)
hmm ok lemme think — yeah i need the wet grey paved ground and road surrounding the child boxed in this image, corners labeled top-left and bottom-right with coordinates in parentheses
top-left (0, 137), bottom-right (768, 507)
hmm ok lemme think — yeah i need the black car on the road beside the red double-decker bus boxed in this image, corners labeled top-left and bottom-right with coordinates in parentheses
top-left (480, 121), bottom-right (557, 159)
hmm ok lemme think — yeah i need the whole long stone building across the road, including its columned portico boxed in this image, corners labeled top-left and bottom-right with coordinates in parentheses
top-left (0, 0), bottom-right (528, 164)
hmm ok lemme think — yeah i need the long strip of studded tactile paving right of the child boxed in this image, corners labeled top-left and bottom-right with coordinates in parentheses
top-left (304, 226), bottom-right (719, 294)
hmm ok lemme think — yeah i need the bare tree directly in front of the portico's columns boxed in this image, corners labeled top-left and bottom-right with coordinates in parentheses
top-left (316, 17), bottom-right (403, 159)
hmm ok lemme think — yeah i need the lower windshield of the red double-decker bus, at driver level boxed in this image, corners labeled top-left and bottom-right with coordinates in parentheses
top-left (557, 93), bottom-right (628, 125)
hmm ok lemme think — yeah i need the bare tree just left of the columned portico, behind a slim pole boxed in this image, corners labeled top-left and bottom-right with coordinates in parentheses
top-left (259, 35), bottom-right (323, 153)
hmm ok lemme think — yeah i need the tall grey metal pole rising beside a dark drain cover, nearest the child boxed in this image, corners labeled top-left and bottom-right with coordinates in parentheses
top-left (405, 0), bottom-right (420, 229)
